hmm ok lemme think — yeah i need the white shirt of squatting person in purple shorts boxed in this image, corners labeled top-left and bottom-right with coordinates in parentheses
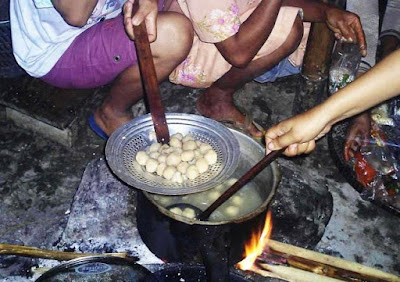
top-left (10, 0), bottom-right (125, 77)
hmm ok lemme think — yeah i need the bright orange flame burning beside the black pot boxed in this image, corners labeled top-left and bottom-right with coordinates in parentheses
top-left (236, 211), bottom-right (272, 270)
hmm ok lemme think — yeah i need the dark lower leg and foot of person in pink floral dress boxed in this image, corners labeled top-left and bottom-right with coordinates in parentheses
top-left (197, 17), bottom-right (303, 136)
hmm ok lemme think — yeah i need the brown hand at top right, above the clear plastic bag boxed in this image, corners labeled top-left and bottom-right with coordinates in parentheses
top-left (326, 7), bottom-right (367, 57)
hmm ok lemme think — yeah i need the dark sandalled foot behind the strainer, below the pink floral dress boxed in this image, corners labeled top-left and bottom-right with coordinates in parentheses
top-left (196, 86), bottom-right (263, 137)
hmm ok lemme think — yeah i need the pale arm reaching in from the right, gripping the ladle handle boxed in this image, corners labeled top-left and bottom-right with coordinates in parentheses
top-left (265, 50), bottom-right (400, 156)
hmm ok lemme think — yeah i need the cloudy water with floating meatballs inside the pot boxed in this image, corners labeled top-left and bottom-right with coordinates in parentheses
top-left (153, 178), bottom-right (263, 221)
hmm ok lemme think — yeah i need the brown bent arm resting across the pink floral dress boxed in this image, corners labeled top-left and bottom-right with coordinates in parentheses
top-left (215, 0), bottom-right (282, 67)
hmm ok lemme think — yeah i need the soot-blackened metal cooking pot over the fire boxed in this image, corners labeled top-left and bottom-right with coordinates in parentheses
top-left (137, 129), bottom-right (281, 280)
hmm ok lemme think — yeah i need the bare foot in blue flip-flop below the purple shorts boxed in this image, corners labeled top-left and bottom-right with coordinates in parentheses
top-left (94, 106), bottom-right (133, 136)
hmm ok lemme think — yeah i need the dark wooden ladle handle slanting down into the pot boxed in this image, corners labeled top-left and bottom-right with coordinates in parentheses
top-left (197, 148), bottom-right (286, 220)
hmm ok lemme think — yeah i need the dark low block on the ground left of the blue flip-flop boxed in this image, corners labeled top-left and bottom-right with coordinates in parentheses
top-left (0, 76), bottom-right (95, 146)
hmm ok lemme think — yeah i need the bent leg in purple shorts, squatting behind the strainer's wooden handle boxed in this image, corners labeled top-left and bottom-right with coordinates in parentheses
top-left (41, 12), bottom-right (193, 135)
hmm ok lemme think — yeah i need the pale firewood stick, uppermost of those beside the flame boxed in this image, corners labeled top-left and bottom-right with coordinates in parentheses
top-left (268, 240), bottom-right (400, 282)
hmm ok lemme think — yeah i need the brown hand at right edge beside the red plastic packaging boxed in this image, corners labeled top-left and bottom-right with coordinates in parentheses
top-left (343, 113), bottom-right (371, 162)
